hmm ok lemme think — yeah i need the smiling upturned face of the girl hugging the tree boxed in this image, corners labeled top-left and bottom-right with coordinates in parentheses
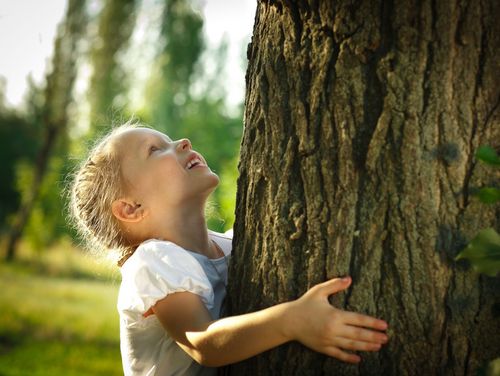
top-left (117, 128), bottom-right (219, 212)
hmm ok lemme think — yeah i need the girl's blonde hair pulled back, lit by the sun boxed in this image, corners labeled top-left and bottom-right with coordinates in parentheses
top-left (68, 122), bottom-right (144, 266)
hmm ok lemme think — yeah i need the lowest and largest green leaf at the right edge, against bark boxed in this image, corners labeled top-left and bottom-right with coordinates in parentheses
top-left (455, 228), bottom-right (500, 277)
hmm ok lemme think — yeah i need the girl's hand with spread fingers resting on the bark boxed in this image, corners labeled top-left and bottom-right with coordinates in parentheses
top-left (288, 277), bottom-right (388, 363)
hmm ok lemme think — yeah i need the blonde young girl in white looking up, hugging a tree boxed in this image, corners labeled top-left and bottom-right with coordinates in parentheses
top-left (71, 125), bottom-right (387, 375)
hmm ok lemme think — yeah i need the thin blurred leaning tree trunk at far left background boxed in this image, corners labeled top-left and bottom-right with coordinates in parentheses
top-left (5, 0), bottom-right (86, 261)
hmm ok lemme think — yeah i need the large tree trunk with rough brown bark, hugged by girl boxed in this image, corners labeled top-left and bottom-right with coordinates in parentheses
top-left (228, 0), bottom-right (500, 375)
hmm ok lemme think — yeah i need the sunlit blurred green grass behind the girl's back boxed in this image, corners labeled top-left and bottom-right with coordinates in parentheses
top-left (0, 239), bottom-right (123, 376)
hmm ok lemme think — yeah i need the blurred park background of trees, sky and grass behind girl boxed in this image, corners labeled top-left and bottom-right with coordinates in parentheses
top-left (0, 0), bottom-right (256, 375)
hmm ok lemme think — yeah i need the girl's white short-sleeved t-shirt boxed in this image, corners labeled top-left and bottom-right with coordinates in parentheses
top-left (118, 231), bottom-right (232, 376)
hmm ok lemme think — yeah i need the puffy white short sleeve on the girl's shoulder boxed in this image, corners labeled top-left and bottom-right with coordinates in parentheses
top-left (118, 240), bottom-right (214, 314)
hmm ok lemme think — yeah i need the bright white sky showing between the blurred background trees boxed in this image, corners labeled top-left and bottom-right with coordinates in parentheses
top-left (0, 0), bottom-right (257, 106)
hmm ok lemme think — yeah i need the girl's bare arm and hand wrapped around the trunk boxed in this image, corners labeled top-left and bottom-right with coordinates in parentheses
top-left (153, 278), bottom-right (387, 367)
